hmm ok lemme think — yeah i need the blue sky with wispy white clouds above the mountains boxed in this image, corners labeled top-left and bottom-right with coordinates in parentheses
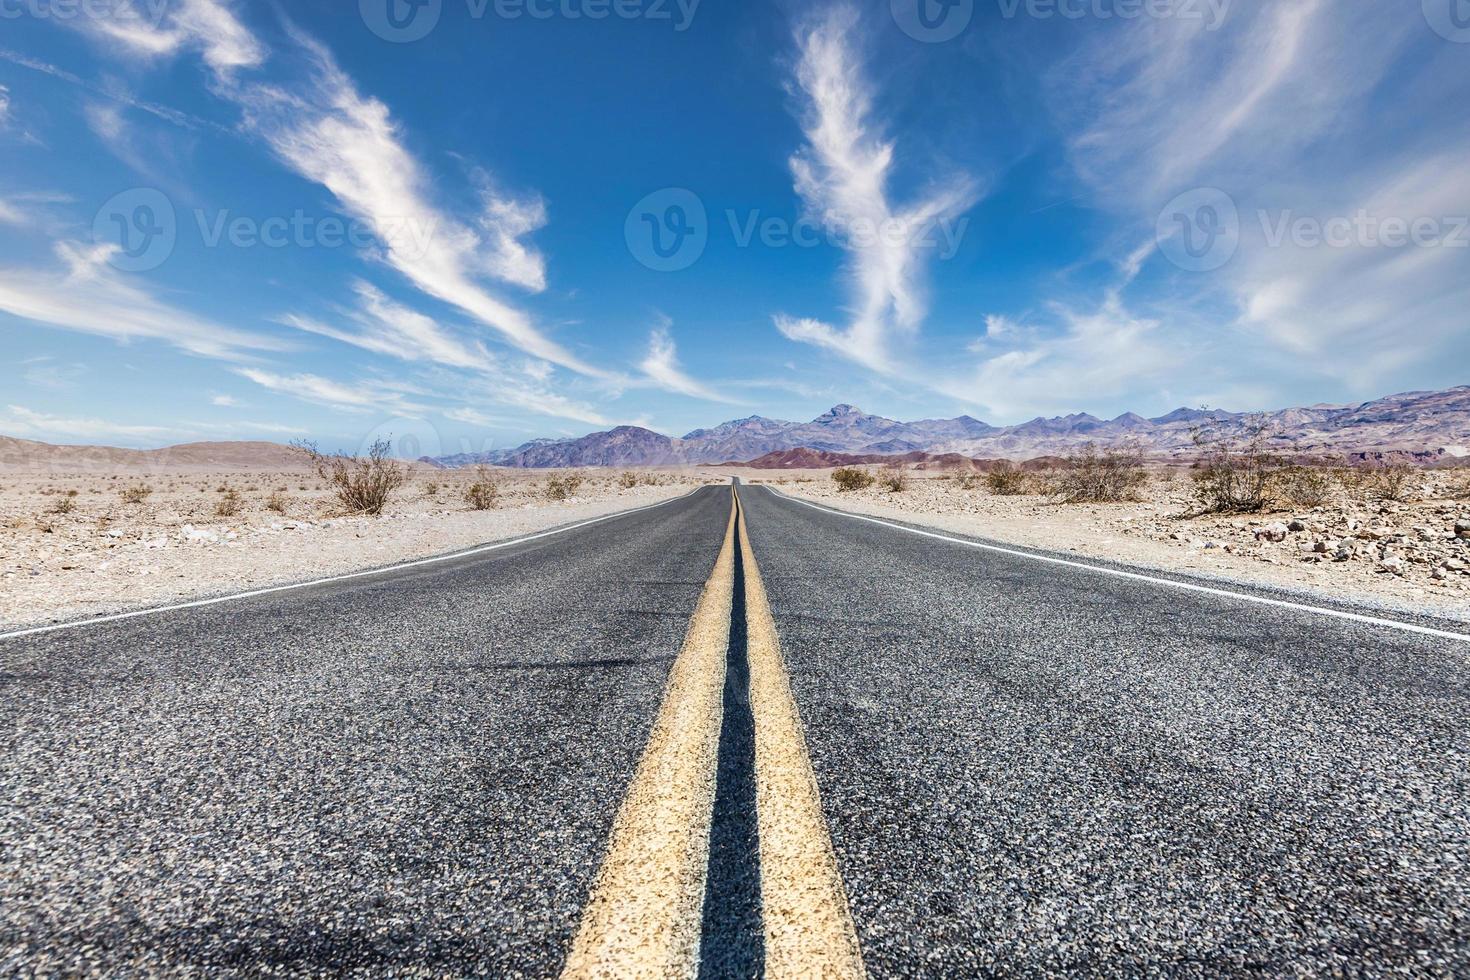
top-left (0, 0), bottom-right (1470, 453)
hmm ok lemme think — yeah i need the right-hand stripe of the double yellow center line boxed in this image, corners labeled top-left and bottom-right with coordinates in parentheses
top-left (739, 493), bottom-right (866, 980)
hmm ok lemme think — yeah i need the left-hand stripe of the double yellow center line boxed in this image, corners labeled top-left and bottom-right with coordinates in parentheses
top-left (563, 495), bottom-right (736, 979)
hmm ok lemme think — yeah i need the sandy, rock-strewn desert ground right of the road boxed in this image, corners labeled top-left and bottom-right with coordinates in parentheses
top-left (726, 470), bottom-right (1470, 620)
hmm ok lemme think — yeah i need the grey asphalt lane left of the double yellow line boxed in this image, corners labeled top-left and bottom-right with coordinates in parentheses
top-left (0, 488), bottom-right (729, 976)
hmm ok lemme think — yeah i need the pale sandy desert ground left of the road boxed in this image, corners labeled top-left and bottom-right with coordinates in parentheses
top-left (0, 470), bottom-right (711, 637)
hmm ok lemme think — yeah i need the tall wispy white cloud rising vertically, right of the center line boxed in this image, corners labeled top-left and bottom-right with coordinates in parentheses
top-left (775, 6), bottom-right (978, 373)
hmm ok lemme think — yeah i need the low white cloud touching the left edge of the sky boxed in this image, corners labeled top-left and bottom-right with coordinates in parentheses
top-left (0, 242), bottom-right (287, 360)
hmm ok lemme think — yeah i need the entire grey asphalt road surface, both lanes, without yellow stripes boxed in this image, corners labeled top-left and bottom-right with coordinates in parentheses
top-left (0, 488), bottom-right (1470, 977)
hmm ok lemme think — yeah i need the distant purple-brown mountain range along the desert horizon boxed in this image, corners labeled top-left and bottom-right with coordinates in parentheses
top-left (423, 385), bottom-right (1470, 469)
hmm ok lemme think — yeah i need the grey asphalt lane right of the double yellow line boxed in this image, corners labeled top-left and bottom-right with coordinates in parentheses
top-left (741, 488), bottom-right (1470, 976)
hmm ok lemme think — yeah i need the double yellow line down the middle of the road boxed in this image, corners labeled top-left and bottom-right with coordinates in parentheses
top-left (563, 494), bottom-right (864, 980)
